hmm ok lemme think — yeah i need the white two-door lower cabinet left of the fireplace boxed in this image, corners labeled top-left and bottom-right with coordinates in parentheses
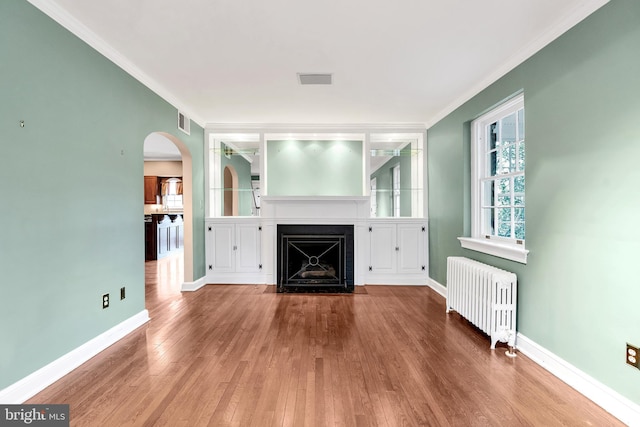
top-left (205, 219), bottom-right (263, 283)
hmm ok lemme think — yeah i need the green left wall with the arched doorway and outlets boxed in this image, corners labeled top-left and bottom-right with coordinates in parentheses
top-left (0, 0), bottom-right (205, 389)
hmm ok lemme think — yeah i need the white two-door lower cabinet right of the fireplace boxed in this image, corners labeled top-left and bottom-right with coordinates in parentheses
top-left (366, 220), bottom-right (427, 284)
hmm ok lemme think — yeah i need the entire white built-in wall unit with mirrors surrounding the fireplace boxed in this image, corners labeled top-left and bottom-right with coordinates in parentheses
top-left (205, 125), bottom-right (429, 285)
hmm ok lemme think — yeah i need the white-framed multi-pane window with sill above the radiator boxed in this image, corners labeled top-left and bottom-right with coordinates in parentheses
top-left (460, 95), bottom-right (527, 263)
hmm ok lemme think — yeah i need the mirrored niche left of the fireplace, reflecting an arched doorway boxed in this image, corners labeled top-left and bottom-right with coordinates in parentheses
top-left (212, 140), bottom-right (260, 216)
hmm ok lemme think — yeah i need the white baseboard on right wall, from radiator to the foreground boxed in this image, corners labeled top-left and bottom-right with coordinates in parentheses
top-left (518, 333), bottom-right (640, 427)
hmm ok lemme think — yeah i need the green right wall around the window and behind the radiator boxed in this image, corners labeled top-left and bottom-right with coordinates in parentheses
top-left (427, 0), bottom-right (640, 403)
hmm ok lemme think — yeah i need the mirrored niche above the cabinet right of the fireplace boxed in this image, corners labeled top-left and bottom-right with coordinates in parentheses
top-left (369, 139), bottom-right (422, 218)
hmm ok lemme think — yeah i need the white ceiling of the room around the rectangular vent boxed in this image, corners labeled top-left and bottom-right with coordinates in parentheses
top-left (30, 0), bottom-right (608, 125)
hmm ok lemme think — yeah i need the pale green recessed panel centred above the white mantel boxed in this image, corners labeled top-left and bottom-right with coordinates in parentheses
top-left (267, 140), bottom-right (362, 196)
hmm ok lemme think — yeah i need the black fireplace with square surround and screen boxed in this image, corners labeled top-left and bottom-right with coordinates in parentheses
top-left (277, 224), bottom-right (354, 292)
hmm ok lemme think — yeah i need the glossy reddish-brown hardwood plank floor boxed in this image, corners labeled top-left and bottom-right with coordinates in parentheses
top-left (29, 257), bottom-right (622, 427)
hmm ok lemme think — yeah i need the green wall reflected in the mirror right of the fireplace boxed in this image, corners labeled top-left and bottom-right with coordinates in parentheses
top-left (370, 148), bottom-right (416, 217)
